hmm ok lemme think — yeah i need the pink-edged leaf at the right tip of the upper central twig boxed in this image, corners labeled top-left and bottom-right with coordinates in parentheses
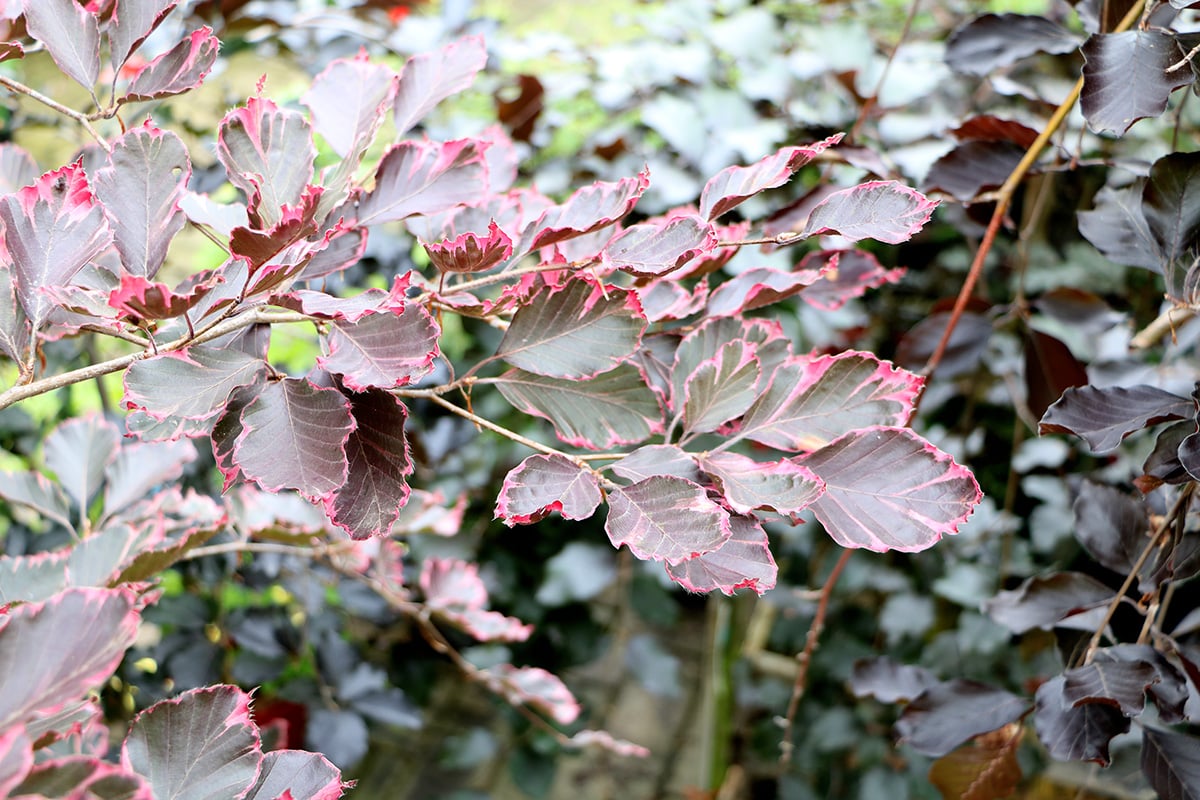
top-left (803, 181), bottom-right (937, 245)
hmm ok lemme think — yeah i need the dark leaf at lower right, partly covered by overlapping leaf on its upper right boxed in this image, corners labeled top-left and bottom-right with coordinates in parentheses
top-left (1033, 675), bottom-right (1129, 766)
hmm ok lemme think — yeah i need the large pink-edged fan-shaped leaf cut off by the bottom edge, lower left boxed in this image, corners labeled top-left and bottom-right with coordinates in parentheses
top-left (121, 686), bottom-right (263, 800)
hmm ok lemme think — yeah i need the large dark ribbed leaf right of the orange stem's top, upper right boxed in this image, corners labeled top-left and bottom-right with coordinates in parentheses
top-left (1080, 30), bottom-right (1195, 136)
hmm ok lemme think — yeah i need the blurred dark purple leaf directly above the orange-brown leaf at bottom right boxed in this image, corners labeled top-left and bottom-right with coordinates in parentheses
top-left (895, 680), bottom-right (1030, 758)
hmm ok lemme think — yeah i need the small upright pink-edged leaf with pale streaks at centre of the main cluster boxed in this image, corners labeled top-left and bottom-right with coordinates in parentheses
top-left (678, 339), bottom-right (762, 433)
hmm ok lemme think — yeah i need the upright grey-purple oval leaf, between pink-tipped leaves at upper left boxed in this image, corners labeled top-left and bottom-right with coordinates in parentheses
top-left (95, 122), bottom-right (192, 278)
